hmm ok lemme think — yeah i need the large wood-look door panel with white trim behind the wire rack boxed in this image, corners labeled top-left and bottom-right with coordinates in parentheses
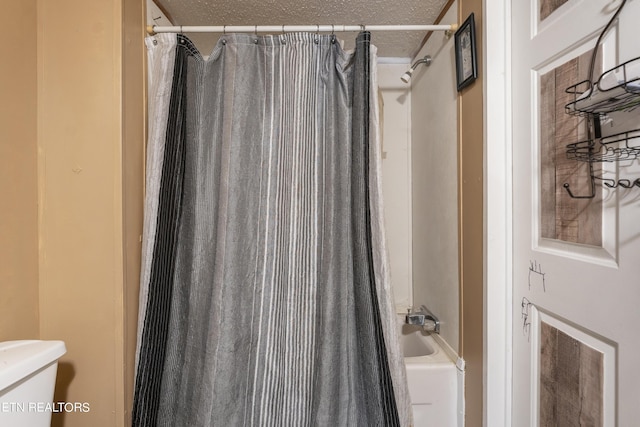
top-left (530, 37), bottom-right (618, 267)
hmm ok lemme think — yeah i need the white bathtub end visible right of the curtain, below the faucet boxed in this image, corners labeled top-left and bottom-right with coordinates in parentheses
top-left (399, 316), bottom-right (464, 427)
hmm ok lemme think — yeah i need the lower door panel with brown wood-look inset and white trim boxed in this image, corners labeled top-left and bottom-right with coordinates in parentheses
top-left (531, 307), bottom-right (616, 426)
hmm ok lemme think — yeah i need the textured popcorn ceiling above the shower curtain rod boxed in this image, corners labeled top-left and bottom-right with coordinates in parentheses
top-left (154, 0), bottom-right (452, 58)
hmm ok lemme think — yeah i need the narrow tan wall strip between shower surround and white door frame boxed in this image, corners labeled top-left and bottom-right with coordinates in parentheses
top-left (458, 0), bottom-right (484, 427)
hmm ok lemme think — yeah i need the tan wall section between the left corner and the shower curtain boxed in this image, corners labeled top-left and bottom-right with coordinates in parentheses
top-left (38, 0), bottom-right (144, 426)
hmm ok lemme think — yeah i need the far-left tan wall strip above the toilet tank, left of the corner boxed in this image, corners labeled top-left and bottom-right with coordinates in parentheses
top-left (0, 0), bottom-right (39, 341)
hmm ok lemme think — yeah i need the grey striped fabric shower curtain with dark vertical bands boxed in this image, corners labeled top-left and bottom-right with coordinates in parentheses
top-left (133, 32), bottom-right (411, 427)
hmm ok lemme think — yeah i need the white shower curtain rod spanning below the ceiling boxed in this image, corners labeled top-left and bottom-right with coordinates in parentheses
top-left (147, 24), bottom-right (458, 34)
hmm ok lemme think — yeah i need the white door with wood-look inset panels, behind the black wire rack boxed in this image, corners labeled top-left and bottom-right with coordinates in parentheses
top-left (511, 0), bottom-right (640, 427)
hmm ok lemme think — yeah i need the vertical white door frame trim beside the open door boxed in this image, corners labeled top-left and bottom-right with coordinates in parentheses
top-left (482, 0), bottom-right (513, 427)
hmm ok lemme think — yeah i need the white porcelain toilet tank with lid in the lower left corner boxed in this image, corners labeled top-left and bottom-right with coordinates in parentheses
top-left (0, 340), bottom-right (66, 427)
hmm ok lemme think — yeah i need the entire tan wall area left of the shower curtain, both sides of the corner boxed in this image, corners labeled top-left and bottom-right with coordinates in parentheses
top-left (0, 0), bottom-right (144, 426)
